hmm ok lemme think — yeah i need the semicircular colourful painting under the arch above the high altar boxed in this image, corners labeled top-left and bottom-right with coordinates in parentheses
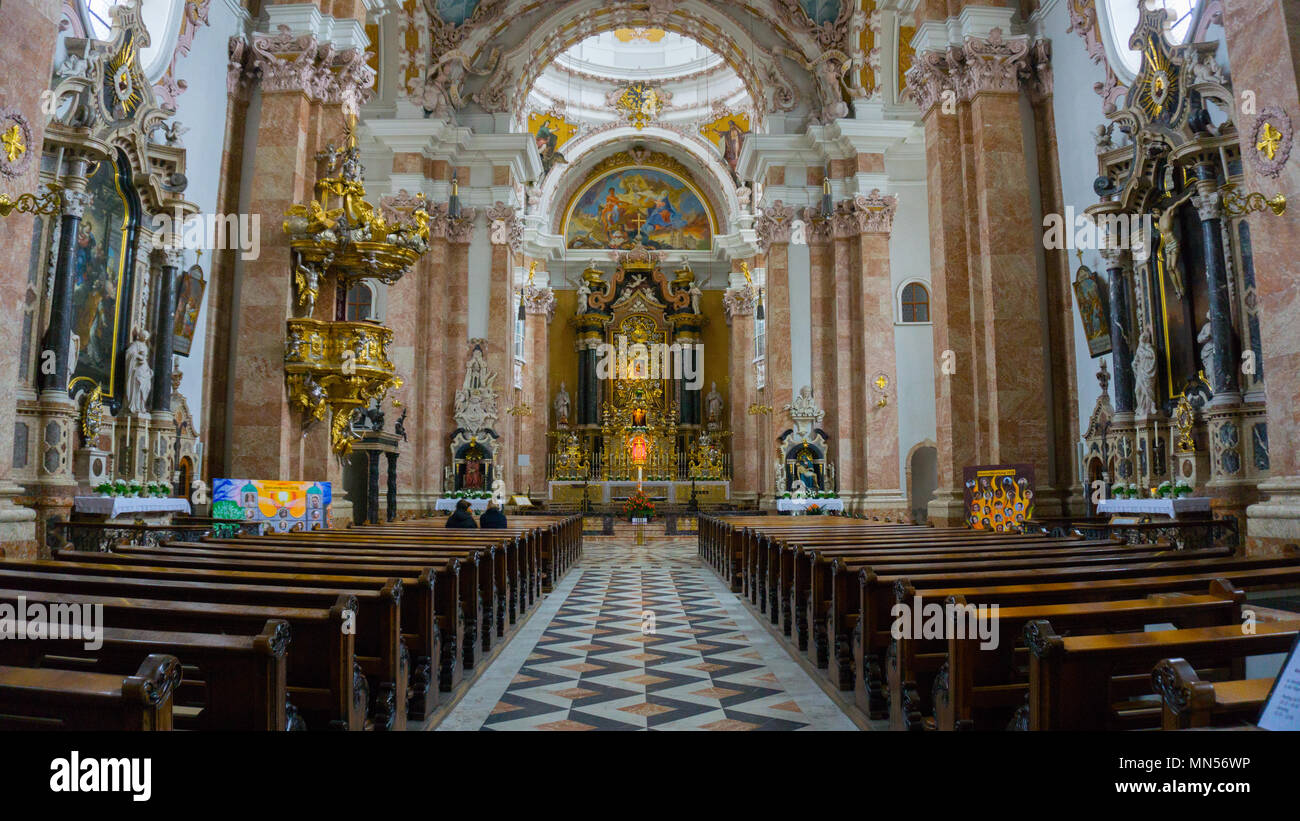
top-left (564, 168), bottom-right (714, 251)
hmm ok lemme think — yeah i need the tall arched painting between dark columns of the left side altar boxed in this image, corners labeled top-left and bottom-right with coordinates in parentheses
top-left (69, 155), bottom-right (130, 396)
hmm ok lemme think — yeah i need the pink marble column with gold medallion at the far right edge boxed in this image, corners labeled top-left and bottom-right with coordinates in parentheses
top-left (1223, 0), bottom-right (1300, 555)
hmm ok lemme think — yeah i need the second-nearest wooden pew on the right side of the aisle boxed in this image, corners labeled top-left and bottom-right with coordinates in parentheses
top-left (1024, 620), bottom-right (1300, 730)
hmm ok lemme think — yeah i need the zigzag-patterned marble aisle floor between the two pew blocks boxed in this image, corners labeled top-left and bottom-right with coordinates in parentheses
top-left (438, 537), bottom-right (857, 730)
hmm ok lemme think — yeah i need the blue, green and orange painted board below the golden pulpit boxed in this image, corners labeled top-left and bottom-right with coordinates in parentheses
top-left (212, 479), bottom-right (333, 533)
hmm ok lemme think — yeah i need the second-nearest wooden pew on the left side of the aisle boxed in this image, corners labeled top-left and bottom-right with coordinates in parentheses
top-left (0, 618), bottom-right (289, 730)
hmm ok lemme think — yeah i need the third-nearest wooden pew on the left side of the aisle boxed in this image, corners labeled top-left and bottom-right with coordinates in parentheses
top-left (0, 587), bottom-right (369, 730)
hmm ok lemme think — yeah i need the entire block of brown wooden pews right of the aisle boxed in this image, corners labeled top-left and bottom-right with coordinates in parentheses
top-left (699, 516), bottom-right (1300, 730)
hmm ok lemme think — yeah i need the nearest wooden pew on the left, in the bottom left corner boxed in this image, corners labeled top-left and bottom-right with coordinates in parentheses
top-left (0, 655), bottom-right (181, 730)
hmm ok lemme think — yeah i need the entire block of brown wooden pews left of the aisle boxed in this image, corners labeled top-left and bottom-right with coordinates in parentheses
top-left (0, 516), bottom-right (582, 730)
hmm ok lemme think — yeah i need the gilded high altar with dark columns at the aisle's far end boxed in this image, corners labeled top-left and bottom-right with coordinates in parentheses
top-left (547, 251), bottom-right (731, 504)
